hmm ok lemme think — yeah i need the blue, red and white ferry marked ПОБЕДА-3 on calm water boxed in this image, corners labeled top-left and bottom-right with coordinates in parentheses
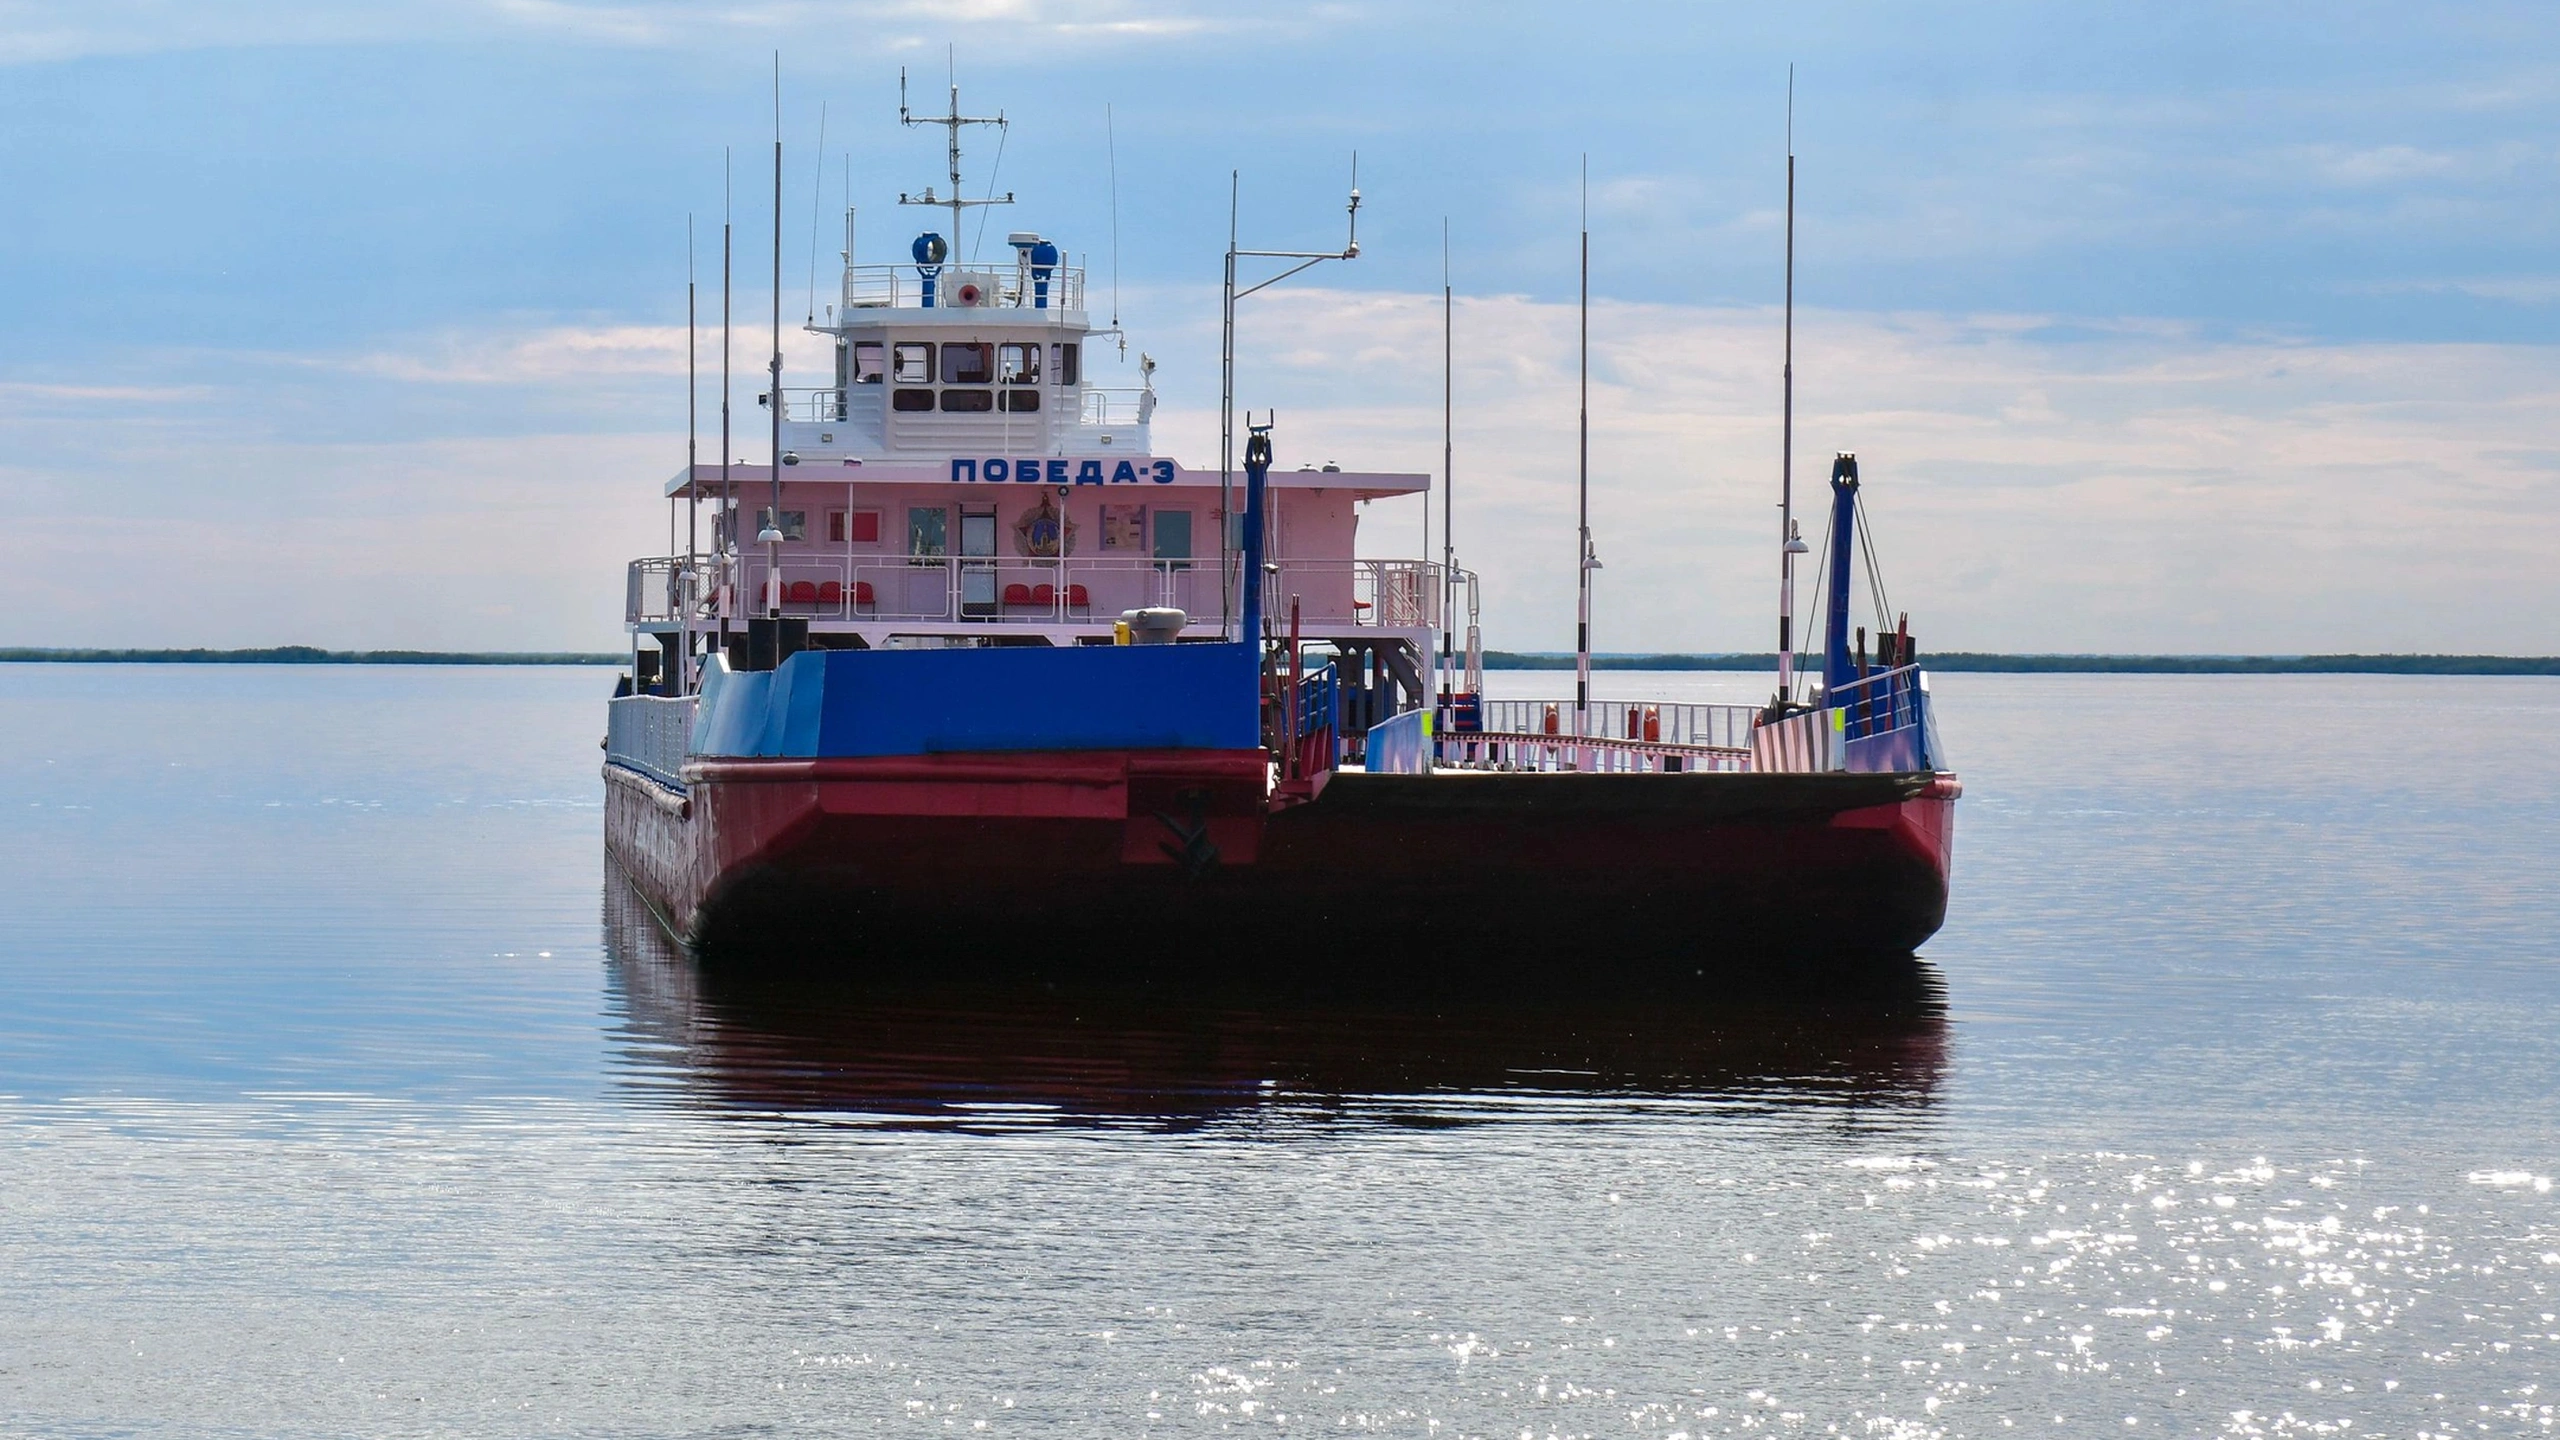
top-left (604, 92), bottom-right (1961, 976)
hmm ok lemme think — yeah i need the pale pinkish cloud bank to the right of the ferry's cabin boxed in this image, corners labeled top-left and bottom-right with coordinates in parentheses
top-left (1160, 292), bottom-right (2560, 651)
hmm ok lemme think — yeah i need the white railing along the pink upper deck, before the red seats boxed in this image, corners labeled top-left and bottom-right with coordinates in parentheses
top-left (625, 551), bottom-right (1441, 633)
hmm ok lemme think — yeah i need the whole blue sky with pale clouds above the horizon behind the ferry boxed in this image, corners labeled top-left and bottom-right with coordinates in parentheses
top-left (0, 0), bottom-right (2560, 653)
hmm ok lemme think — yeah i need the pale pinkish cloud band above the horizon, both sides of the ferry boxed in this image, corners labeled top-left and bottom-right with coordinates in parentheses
top-left (0, 287), bottom-right (2560, 651)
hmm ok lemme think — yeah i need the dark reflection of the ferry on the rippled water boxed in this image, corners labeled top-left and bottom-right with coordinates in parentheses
top-left (604, 881), bottom-right (1946, 1122)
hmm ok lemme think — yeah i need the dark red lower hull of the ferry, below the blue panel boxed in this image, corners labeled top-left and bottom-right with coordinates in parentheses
top-left (604, 751), bottom-right (1956, 971)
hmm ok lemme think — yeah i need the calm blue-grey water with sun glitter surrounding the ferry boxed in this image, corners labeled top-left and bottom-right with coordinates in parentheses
top-left (0, 666), bottom-right (2560, 1437)
